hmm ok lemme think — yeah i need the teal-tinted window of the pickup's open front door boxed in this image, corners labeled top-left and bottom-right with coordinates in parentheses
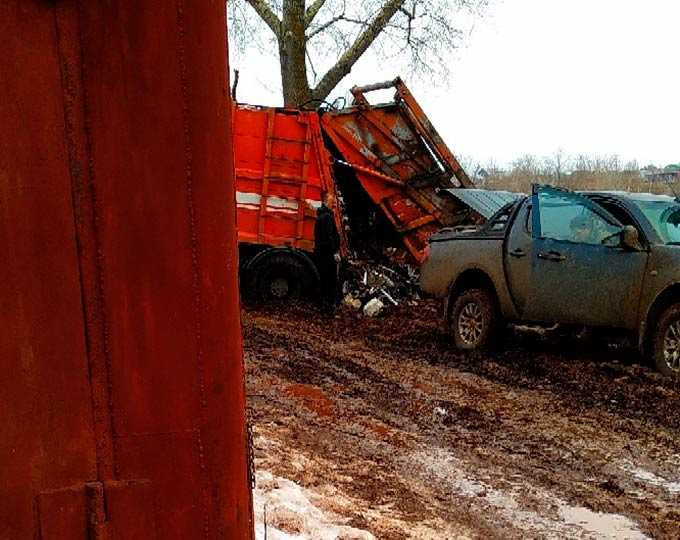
top-left (534, 189), bottom-right (621, 246)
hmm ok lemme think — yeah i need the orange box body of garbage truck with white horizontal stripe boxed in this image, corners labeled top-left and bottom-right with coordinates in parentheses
top-left (234, 105), bottom-right (340, 251)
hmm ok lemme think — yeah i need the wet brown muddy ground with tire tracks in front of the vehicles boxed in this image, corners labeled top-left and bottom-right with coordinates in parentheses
top-left (243, 302), bottom-right (680, 539)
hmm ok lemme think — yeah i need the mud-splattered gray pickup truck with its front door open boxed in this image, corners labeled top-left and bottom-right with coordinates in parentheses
top-left (421, 185), bottom-right (680, 375)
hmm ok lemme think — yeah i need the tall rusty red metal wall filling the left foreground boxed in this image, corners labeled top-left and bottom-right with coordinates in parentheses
top-left (0, 0), bottom-right (252, 539)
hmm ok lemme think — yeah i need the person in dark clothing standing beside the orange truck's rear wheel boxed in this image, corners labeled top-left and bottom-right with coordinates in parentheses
top-left (314, 193), bottom-right (340, 313)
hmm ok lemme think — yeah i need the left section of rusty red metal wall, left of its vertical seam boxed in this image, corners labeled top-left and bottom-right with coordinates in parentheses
top-left (0, 0), bottom-right (97, 539)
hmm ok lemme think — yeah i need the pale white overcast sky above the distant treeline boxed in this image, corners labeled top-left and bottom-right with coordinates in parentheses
top-left (232, 0), bottom-right (680, 166)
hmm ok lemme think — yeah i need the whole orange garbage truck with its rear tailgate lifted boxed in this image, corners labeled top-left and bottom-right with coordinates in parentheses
top-left (234, 79), bottom-right (472, 298)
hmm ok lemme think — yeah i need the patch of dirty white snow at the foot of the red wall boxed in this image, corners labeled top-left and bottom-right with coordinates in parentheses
top-left (253, 471), bottom-right (375, 540)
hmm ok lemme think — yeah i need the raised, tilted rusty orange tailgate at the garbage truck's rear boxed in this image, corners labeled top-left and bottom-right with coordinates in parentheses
top-left (321, 78), bottom-right (473, 262)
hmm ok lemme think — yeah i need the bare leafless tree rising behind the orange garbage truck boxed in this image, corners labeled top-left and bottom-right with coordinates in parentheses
top-left (227, 0), bottom-right (490, 106)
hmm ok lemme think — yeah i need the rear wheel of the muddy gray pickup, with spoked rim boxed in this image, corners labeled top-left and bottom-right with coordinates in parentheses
top-left (449, 289), bottom-right (498, 351)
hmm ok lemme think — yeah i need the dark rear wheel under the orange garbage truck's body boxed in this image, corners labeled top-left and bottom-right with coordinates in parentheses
top-left (253, 253), bottom-right (313, 303)
